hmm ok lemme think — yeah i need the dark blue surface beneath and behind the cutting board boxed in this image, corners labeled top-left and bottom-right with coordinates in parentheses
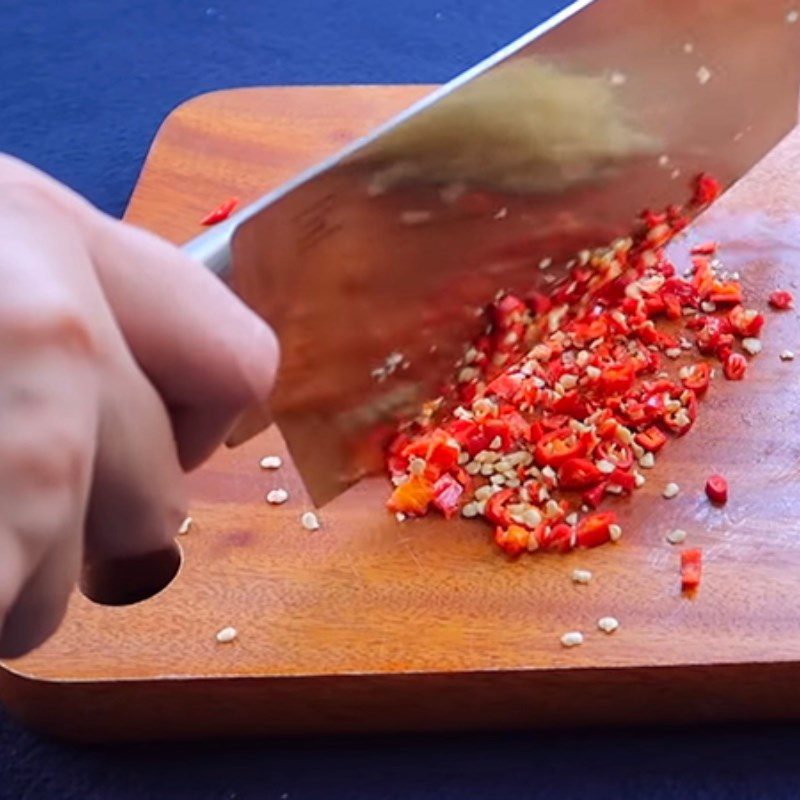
top-left (0, 0), bottom-right (800, 800)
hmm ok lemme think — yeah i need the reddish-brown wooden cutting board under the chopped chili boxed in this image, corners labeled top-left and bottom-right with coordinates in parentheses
top-left (0, 86), bottom-right (800, 739)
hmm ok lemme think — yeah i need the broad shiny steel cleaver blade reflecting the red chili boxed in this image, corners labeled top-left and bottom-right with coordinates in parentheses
top-left (186, 0), bottom-right (800, 505)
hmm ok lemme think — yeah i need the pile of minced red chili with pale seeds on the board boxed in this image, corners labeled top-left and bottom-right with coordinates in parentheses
top-left (387, 175), bottom-right (764, 555)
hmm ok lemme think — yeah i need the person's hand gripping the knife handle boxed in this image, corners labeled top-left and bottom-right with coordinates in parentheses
top-left (0, 155), bottom-right (278, 658)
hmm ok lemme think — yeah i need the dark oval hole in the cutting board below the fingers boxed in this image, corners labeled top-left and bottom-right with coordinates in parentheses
top-left (80, 542), bottom-right (183, 606)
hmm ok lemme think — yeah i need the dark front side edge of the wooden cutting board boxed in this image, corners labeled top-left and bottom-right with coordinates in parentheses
top-left (0, 662), bottom-right (800, 742)
